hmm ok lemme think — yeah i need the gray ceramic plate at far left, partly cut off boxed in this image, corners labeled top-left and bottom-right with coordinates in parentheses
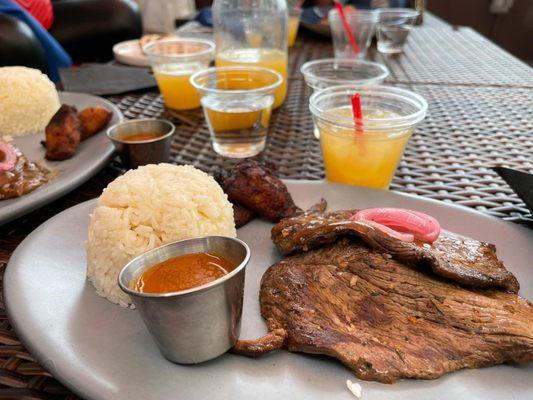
top-left (0, 92), bottom-right (124, 225)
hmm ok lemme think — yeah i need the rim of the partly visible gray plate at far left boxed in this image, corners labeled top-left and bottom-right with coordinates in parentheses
top-left (0, 91), bottom-right (121, 226)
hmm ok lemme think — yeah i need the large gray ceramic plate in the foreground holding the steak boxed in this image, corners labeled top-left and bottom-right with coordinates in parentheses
top-left (4, 182), bottom-right (533, 400)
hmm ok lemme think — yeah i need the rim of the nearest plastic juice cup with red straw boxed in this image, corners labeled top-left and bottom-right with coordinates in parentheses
top-left (309, 85), bottom-right (428, 131)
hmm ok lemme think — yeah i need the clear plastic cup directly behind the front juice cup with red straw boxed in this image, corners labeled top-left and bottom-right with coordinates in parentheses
top-left (300, 58), bottom-right (389, 139)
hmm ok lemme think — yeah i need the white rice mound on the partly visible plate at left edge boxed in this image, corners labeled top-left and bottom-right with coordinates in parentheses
top-left (0, 67), bottom-right (60, 137)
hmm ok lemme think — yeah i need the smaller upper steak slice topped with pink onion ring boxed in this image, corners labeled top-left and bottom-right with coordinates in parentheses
top-left (272, 210), bottom-right (520, 293)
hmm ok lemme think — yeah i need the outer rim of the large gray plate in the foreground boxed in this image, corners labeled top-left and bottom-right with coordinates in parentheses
top-left (3, 179), bottom-right (529, 399)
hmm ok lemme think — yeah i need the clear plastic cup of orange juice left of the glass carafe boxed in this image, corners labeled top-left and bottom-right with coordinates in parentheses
top-left (144, 38), bottom-right (215, 110)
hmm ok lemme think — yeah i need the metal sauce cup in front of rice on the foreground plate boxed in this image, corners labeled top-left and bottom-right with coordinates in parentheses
top-left (118, 236), bottom-right (250, 364)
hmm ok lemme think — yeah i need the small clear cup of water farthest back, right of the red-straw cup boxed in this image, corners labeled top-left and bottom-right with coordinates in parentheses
top-left (377, 8), bottom-right (420, 54)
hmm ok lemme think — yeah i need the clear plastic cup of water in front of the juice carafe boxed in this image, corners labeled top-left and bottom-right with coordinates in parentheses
top-left (191, 67), bottom-right (283, 158)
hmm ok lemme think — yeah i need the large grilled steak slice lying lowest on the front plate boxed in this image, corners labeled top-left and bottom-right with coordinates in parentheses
top-left (234, 239), bottom-right (533, 383)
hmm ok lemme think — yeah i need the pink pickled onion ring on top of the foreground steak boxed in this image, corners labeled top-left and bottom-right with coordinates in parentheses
top-left (351, 208), bottom-right (440, 243)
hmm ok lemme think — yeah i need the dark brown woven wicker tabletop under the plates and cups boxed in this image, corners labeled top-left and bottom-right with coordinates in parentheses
top-left (0, 14), bottom-right (533, 399)
